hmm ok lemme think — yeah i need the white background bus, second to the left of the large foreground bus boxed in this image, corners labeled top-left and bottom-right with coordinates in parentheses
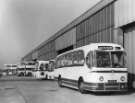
top-left (33, 60), bottom-right (49, 79)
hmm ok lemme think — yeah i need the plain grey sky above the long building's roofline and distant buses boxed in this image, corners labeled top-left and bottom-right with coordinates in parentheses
top-left (0, 0), bottom-right (100, 68)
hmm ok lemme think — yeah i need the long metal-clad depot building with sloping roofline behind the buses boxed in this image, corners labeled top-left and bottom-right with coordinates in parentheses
top-left (21, 0), bottom-right (135, 88)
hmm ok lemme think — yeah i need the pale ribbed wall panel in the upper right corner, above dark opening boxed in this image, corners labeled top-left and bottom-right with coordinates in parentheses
top-left (115, 0), bottom-right (135, 28)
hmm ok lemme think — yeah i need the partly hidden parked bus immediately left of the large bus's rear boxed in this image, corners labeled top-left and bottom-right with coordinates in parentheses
top-left (45, 60), bottom-right (55, 80)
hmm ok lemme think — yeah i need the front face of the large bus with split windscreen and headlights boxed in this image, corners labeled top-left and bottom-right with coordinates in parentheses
top-left (86, 45), bottom-right (128, 92)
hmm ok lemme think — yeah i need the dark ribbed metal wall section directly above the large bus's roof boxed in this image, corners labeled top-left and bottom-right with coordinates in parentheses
top-left (76, 3), bottom-right (114, 47)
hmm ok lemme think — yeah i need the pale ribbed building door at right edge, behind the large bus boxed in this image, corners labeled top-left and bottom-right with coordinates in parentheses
top-left (124, 27), bottom-right (135, 88)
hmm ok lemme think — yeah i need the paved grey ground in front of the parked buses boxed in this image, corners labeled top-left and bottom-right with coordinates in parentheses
top-left (0, 80), bottom-right (135, 103)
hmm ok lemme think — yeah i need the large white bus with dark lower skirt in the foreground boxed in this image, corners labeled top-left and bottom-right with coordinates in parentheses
top-left (55, 43), bottom-right (128, 93)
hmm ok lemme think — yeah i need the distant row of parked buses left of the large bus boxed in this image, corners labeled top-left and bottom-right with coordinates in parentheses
top-left (17, 60), bottom-right (54, 79)
